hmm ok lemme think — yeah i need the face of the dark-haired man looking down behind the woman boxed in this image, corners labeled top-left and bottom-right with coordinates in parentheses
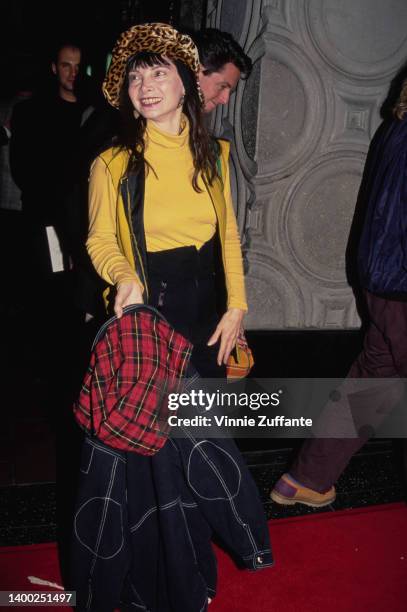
top-left (199, 62), bottom-right (240, 113)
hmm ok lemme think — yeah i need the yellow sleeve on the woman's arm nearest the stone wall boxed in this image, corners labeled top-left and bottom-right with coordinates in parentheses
top-left (221, 142), bottom-right (248, 311)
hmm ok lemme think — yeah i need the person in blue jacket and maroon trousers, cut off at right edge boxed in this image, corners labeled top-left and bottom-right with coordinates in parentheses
top-left (270, 79), bottom-right (407, 507)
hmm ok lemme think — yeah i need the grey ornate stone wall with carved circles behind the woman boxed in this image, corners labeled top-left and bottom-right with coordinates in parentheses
top-left (208, 0), bottom-right (407, 329)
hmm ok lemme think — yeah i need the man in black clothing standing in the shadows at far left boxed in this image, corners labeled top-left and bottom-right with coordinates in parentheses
top-left (10, 38), bottom-right (104, 314)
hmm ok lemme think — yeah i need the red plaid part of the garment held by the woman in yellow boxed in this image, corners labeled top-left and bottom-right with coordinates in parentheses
top-left (74, 306), bottom-right (192, 455)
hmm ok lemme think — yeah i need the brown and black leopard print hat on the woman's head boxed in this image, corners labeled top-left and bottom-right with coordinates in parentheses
top-left (102, 23), bottom-right (204, 108)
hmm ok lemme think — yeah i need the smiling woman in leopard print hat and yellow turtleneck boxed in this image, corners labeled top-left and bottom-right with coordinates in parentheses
top-left (88, 26), bottom-right (247, 376)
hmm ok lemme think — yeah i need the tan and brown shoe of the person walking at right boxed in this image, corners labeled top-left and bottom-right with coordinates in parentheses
top-left (270, 474), bottom-right (336, 508)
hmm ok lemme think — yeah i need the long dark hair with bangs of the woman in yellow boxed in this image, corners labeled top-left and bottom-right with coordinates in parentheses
top-left (117, 51), bottom-right (217, 192)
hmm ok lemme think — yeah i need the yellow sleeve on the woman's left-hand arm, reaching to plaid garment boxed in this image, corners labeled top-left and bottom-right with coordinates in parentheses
top-left (86, 157), bottom-right (143, 289)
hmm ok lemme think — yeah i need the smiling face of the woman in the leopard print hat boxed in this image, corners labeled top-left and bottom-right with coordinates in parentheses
top-left (128, 58), bottom-right (185, 133)
